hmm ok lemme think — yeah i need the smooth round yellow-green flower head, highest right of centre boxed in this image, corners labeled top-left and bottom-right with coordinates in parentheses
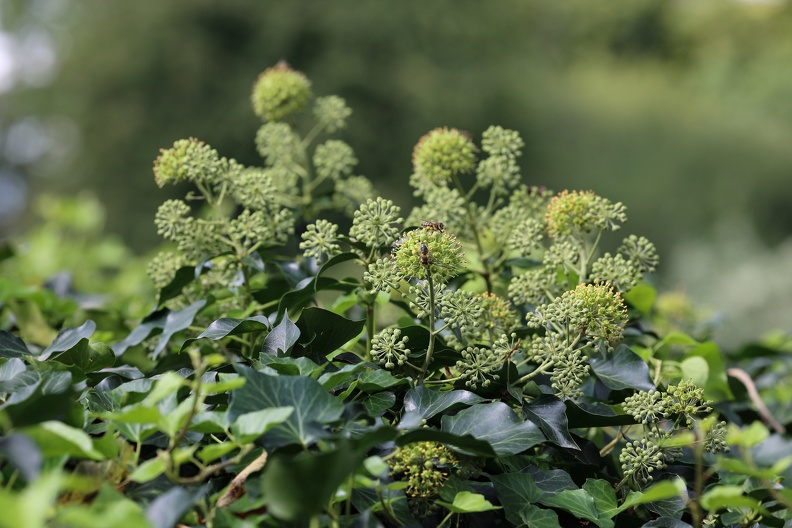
top-left (413, 128), bottom-right (476, 185)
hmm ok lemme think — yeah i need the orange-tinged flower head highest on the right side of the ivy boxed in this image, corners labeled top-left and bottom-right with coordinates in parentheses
top-left (545, 191), bottom-right (627, 238)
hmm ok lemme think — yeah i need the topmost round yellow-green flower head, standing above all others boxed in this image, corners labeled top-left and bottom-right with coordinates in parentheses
top-left (252, 61), bottom-right (311, 121)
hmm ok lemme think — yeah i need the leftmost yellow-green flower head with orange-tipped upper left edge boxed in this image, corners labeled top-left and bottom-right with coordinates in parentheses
top-left (154, 138), bottom-right (230, 187)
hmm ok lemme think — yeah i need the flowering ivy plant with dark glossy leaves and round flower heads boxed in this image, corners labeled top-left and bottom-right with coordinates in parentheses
top-left (0, 63), bottom-right (792, 528)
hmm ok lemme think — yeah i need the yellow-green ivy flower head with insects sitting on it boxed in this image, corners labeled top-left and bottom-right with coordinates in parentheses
top-left (393, 228), bottom-right (464, 283)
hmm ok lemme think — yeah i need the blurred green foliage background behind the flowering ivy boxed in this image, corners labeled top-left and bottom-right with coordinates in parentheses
top-left (0, 0), bottom-right (792, 338)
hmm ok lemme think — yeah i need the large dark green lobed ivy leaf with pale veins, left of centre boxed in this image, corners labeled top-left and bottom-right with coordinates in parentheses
top-left (228, 364), bottom-right (344, 447)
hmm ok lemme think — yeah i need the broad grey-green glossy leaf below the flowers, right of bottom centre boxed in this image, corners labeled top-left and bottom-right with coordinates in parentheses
top-left (442, 402), bottom-right (545, 456)
